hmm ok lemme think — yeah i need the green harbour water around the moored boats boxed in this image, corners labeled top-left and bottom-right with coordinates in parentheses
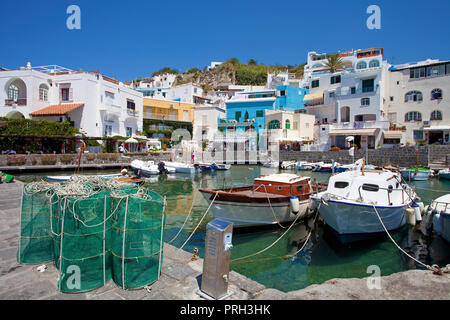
top-left (16, 165), bottom-right (450, 292)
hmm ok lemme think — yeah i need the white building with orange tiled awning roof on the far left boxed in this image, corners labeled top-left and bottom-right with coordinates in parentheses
top-left (0, 63), bottom-right (143, 137)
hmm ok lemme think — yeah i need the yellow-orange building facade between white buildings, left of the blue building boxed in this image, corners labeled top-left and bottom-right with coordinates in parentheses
top-left (144, 97), bottom-right (195, 123)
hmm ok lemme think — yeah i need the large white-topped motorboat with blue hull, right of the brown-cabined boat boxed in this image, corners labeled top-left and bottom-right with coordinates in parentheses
top-left (311, 159), bottom-right (416, 242)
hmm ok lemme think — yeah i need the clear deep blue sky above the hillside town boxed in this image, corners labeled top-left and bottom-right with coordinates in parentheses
top-left (0, 0), bottom-right (450, 81)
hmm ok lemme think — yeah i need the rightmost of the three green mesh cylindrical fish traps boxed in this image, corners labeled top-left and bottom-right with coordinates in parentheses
top-left (112, 189), bottom-right (165, 289)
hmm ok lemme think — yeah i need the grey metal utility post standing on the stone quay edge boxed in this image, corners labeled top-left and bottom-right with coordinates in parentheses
top-left (198, 219), bottom-right (233, 300)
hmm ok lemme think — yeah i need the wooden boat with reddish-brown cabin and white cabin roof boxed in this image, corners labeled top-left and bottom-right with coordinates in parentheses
top-left (199, 174), bottom-right (326, 228)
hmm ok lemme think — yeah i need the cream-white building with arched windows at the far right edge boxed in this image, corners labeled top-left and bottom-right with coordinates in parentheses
top-left (384, 59), bottom-right (450, 144)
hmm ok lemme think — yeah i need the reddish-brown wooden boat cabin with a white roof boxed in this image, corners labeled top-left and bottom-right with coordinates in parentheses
top-left (252, 173), bottom-right (311, 197)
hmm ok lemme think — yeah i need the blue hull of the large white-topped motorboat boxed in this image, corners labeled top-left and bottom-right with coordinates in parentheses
top-left (313, 198), bottom-right (407, 240)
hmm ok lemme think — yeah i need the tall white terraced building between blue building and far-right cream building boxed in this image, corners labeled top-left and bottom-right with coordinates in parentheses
top-left (303, 48), bottom-right (389, 149)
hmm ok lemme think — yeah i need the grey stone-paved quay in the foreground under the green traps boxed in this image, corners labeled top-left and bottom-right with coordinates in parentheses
top-left (0, 182), bottom-right (450, 300)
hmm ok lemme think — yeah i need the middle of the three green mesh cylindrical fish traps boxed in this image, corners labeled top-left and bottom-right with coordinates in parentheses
top-left (55, 191), bottom-right (112, 292)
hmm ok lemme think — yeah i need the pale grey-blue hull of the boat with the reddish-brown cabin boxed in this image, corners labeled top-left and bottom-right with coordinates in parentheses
top-left (203, 193), bottom-right (309, 228)
